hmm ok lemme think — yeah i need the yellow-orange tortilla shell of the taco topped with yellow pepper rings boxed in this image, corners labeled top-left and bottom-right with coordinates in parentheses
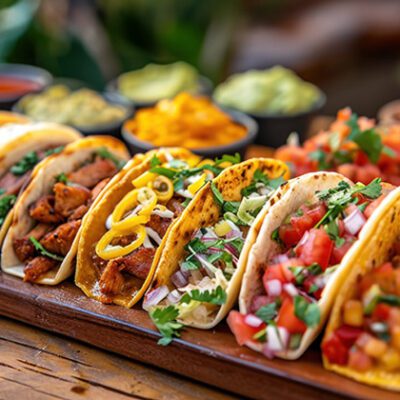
top-left (75, 148), bottom-right (198, 308)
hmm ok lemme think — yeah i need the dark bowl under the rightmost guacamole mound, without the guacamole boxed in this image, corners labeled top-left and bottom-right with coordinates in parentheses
top-left (242, 92), bottom-right (326, 148)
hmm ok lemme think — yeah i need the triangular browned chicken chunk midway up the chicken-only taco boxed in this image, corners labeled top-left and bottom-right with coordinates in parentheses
top-left (53, 182), bottom-right (91, 218)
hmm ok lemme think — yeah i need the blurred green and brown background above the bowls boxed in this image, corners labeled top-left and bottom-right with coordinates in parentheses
top-left (0, 0), bottom-right (400, 116)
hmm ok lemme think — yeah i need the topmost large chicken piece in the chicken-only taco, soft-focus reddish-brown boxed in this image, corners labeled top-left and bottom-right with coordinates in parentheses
top-left (68, 157), bottom-right (117, 188)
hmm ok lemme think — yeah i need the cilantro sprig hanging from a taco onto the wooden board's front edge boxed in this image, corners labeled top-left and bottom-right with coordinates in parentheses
top-left (150, 305), bottom-right (183, 346)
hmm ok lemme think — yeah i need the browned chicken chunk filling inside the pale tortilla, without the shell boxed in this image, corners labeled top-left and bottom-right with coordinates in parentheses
top-left (13, 148), bottom-right (124, 282)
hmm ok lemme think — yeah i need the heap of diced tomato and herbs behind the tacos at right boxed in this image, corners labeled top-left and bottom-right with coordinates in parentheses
top-left (275, 108), bottom-right (400, 186)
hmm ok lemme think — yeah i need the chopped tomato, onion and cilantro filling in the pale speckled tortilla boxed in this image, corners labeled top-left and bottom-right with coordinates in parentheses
top-left (228, 178), bottom-right (390, 358)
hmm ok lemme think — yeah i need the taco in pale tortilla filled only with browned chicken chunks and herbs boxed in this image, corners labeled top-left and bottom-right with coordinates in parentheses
top-left (1, 136), bottom-right (129, 285)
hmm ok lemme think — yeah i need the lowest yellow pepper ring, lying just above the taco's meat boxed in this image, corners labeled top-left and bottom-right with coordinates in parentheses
top-left (96, 225), bottom-right (146, 260)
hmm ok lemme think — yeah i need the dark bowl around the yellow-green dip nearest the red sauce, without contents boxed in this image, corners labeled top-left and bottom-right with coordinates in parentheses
top-left (12, 93), bottom-right (134, 139)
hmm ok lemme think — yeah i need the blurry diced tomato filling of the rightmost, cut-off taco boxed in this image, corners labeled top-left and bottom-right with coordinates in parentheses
top-left (322, 253), bottom-right (400, 372)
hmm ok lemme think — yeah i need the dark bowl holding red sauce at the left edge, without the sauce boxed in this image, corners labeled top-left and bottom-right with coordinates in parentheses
top-left (0, 64), bottom-right (53, 110)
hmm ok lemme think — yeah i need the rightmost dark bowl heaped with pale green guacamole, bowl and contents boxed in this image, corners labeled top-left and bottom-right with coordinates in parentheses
top-left (213, 66), bottom-right (326, 147)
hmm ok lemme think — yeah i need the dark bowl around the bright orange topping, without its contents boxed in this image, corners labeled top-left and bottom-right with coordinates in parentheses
top-left (122, 110), bottom-right (258, 159)
